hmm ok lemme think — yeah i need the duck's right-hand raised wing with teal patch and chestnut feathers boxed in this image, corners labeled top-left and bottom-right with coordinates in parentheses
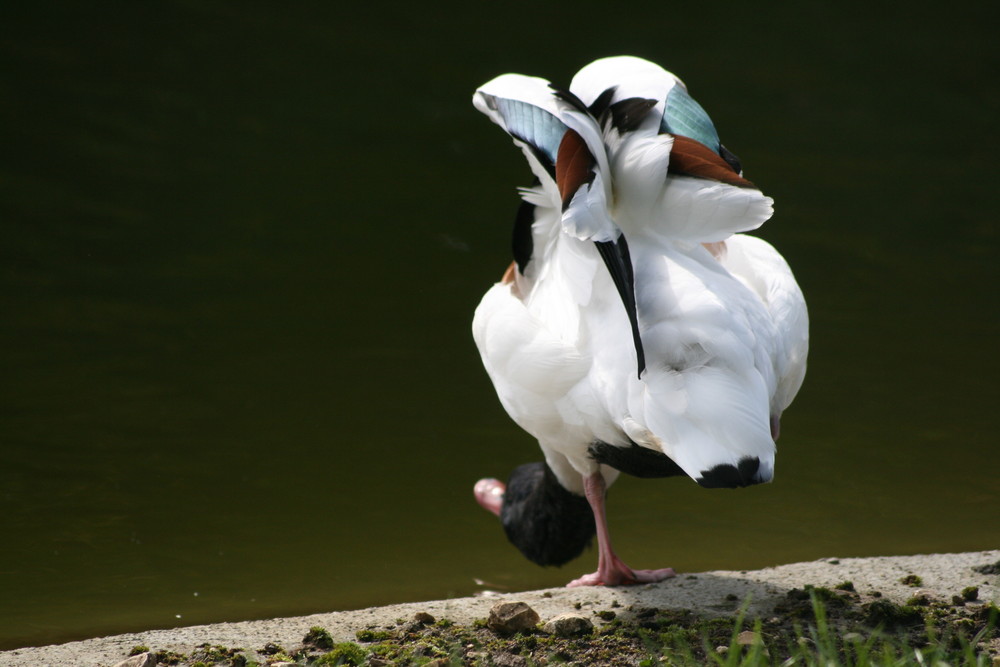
top-left (570, 56), bottom-right (773, 243)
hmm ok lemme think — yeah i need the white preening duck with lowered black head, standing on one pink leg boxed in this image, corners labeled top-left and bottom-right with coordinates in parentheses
top-left (472, 56), bottom-right (808, 586)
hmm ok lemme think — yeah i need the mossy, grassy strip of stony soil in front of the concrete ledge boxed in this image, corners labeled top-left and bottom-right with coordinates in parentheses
top-left (127, 582), bottom-right (1000, 667)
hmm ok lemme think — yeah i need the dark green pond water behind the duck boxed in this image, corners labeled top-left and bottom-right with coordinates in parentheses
top-left (0, 2), bottom-right (1000, 648)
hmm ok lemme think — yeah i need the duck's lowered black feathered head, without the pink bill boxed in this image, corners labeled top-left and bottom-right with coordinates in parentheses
top-left (500, 462), bottom-right (596, 565)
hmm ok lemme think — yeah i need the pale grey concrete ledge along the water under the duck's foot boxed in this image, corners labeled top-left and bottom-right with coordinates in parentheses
top-left (0, 550), bottom-right (1000, 667)
